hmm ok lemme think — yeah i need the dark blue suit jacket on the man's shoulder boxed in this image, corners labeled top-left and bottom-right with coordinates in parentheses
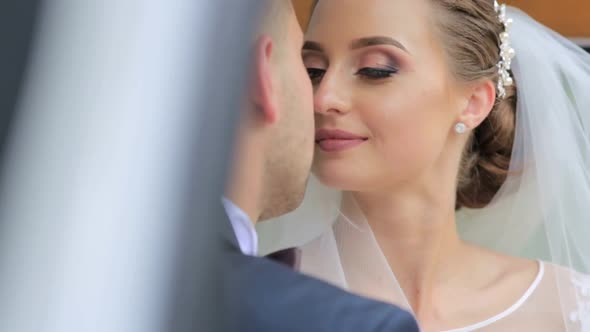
top-left (222, 214), bottom-right (418, 332)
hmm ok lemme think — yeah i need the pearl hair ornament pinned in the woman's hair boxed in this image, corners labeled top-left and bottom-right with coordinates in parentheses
top-left (494, 0), bottom-right (516, 99)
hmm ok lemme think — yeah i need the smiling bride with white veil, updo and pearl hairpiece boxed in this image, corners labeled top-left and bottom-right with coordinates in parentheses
top-left (266, 0), bottom-right (590, 331)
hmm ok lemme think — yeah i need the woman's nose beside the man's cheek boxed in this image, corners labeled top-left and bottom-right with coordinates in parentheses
top-left (314, 71), bottom-right (350, 115)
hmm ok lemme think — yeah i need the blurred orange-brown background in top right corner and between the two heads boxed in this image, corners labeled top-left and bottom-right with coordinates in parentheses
top-left (293, 0), bottom-right (590, 52)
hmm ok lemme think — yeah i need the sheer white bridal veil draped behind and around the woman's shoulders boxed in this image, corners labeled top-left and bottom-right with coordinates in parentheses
top-left (268, 8), bottom-right (590, 331)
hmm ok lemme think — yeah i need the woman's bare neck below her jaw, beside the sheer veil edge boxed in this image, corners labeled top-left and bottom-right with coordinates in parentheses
top-left (352, 192), bottom-right (472, 310)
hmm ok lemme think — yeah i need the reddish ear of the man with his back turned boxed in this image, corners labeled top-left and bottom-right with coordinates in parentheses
top-left (251, 35), bottom-right (279, 124)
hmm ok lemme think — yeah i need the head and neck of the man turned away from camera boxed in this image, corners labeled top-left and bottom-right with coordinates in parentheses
top-left (230, 0), bottom-right (314, 220)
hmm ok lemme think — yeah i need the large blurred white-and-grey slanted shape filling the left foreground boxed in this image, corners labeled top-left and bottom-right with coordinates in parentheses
top-left (0, 0), bottom-right (260, 332)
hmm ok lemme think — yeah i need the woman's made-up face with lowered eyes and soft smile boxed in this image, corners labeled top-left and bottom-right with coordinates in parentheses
top-left (303, 0), bottom-right (464, 191)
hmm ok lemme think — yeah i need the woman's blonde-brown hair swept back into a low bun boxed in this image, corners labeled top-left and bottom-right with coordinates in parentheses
top-left (432, 0), bottom-right (517, 209)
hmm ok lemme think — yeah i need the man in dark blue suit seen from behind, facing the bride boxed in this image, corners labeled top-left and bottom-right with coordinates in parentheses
top-left (222, 0), bottom-right (418, 332)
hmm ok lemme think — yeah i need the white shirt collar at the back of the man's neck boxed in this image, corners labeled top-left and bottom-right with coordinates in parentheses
top-left (221, 197), bottom-right (258, 256)
